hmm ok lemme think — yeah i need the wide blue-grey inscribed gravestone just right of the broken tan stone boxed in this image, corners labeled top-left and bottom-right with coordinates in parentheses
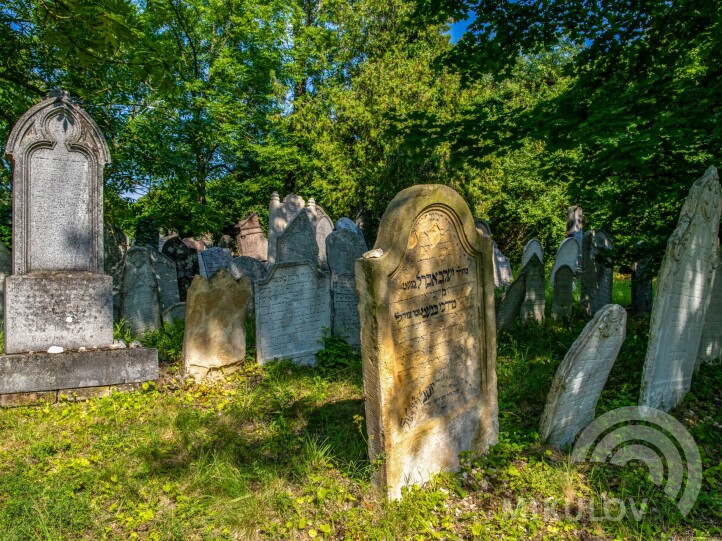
top-left (253, 260), bottom-right (331, 365)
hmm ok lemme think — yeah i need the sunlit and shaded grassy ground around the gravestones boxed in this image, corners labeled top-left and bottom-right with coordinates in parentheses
top-left (0, 276), bottom-right (722, 541)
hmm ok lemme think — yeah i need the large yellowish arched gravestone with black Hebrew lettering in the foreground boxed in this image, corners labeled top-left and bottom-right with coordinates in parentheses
top-left (356, 184), bottom-right (498, 498)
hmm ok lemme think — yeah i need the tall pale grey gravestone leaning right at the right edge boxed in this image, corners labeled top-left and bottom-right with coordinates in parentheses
top-left (639, 167), bottom-right (721, 411)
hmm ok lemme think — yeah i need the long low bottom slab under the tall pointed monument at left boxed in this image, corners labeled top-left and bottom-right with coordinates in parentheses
top-left (0, 348), bottom-right (158, 396)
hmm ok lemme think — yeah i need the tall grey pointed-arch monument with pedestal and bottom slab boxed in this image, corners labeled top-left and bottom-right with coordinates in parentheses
top-left (0, 93), bottom-right (158, 394)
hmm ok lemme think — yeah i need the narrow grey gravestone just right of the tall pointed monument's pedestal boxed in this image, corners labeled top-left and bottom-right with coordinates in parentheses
top-left (121, 246), bottom-right (162, 335)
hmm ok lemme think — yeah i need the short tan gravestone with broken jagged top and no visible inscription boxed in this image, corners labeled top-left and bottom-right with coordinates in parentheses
top-left (183, 269), bottom-right (251, 382)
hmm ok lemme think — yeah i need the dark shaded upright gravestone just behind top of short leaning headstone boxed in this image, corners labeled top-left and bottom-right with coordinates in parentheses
top-left (580, 229), bottom-right (614, 316)
